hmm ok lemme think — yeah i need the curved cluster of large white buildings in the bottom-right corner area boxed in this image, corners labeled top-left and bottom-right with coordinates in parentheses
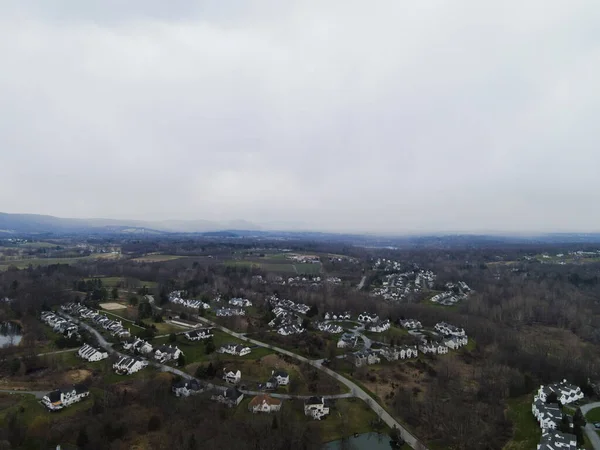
top-left (531, 380), bottom-right (583, 450)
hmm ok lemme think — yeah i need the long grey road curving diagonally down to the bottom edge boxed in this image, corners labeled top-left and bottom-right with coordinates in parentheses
top-left (198, 317), bottom-right (427, 450)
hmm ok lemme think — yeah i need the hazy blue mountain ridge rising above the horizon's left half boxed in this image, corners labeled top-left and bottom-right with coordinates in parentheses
top-left (0, 213), bottom-right (260, 234)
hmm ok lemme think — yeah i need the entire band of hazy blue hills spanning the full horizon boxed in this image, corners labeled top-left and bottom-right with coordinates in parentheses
top-left (0, 213), bottom-right (600, 249)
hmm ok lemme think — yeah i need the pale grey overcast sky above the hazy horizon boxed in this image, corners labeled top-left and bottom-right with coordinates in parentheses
top-left (0, 0), bottom-right (600, 233)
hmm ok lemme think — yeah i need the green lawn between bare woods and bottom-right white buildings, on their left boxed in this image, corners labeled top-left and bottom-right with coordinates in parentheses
top-left (504, 395), bottom-right (542, 450)
